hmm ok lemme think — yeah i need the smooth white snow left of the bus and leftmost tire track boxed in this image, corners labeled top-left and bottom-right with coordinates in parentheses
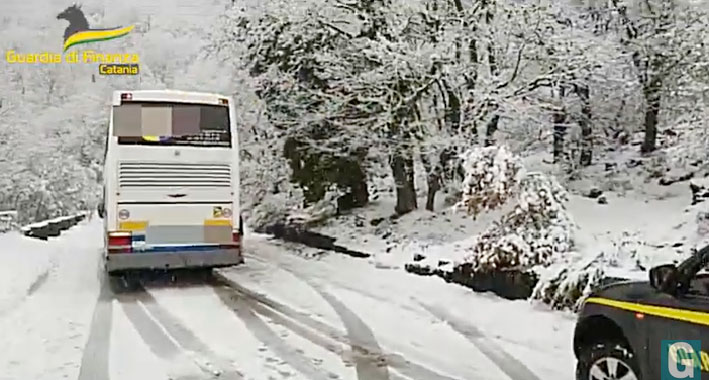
top-left (0, 221), bottom-right (102, 380)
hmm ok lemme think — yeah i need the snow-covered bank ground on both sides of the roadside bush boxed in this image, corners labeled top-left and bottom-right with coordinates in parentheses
top-left (306, 151), bottom-right (709, 296)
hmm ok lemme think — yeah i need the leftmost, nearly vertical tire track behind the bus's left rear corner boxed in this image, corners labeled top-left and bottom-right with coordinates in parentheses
top-left (78, 277), bottom-right (113, 380)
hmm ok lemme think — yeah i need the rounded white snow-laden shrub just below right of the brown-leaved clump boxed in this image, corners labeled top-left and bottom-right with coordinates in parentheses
top-left (470, 173), bottom-right (574, 270)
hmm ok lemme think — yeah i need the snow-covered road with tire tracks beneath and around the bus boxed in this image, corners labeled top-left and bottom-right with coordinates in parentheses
top-left (0, 220), bottom-right (575, 380)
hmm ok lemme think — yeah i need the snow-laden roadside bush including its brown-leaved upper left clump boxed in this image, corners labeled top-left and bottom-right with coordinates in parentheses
top-left (460, 147), bottom-right (575, 271)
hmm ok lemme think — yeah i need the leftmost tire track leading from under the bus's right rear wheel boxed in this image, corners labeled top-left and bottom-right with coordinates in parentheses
top-left (214, 284), bottom-right (339, 380)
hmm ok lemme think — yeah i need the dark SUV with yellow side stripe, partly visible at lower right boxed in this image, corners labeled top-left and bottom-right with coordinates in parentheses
top-left (574, 246), bottom-right (709, 380)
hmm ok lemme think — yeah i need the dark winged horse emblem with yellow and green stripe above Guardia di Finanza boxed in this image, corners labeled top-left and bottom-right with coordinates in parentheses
top-left (57, 4), bottom-right (133, 52)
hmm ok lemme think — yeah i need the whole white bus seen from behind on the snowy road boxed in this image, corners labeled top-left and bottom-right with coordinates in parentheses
top-left (99, 90), bottom-right (243, 273)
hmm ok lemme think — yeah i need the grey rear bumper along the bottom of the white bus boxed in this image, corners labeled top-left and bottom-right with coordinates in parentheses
top-left (106, 248), bottom-right (244, 273)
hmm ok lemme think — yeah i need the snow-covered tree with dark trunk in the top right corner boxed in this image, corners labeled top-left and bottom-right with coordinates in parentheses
top-left (589, 0), bottom-right (707, 153)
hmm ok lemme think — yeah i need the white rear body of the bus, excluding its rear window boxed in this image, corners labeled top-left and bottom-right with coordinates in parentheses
top-left (104, 90), bottom-right (243, 272)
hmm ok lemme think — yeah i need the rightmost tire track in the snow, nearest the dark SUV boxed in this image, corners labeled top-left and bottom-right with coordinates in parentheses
top-left (421, 303), bottom-right (539, 380)
